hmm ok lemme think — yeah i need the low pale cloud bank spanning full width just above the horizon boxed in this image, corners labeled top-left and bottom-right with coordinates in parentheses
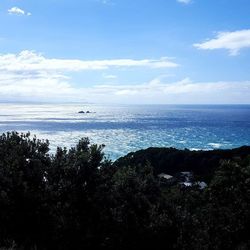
top-left (0, 71), bottom-right (250, 104)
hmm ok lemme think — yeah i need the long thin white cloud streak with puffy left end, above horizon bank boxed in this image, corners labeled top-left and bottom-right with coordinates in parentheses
top-left (0, 50), bottom-right (178, 72)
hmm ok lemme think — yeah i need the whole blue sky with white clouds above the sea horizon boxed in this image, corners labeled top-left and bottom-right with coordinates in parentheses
top-left (0, 0), bottom-right (250, 104)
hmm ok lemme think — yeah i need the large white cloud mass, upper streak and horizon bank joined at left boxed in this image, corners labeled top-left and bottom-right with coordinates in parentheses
top-left (0, 51), bottom-right (250, 103)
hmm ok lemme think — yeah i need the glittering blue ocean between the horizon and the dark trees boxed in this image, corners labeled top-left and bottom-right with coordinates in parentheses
top-left (0, 104), bottom-right (250, 160)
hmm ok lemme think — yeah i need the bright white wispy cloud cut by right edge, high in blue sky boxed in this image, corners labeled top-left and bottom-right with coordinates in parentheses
top-left (194, 29), bottom-right (250, 56)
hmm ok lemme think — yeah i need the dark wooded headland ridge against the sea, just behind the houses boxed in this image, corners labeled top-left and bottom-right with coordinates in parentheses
top-left (114, 146), bottom-right (250, 182)
